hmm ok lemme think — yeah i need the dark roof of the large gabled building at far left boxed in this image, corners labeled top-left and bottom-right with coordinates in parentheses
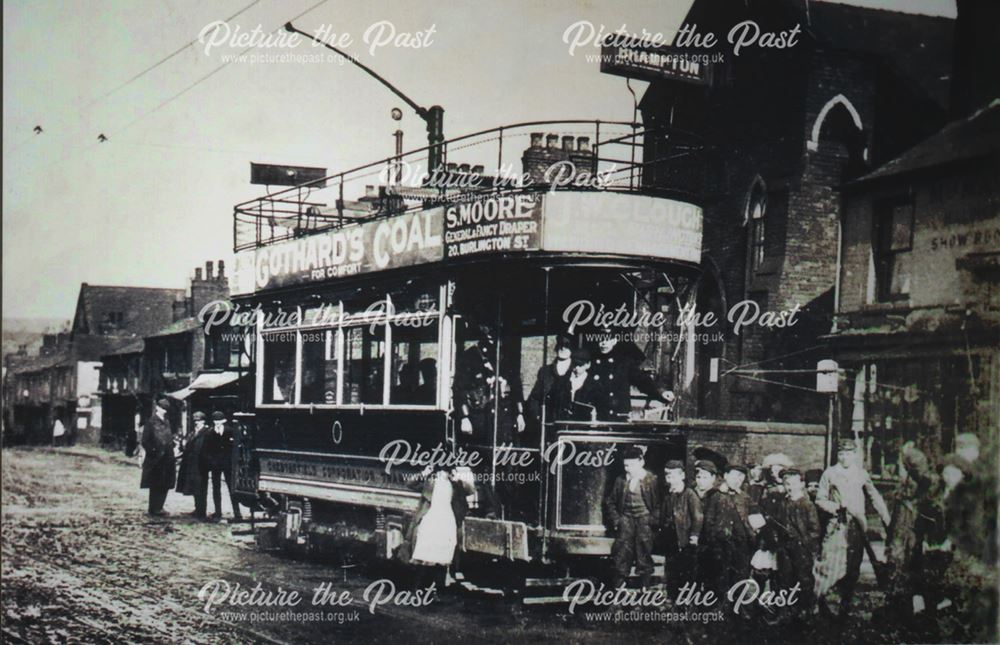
top-left (73, 282), bottom-right (185, 338)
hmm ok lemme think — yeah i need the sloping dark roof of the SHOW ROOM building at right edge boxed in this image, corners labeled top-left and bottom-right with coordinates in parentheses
top-left (849, 99), bottom-right (1000, 185)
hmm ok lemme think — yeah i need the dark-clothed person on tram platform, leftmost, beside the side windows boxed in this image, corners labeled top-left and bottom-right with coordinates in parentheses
top-left (453, 317), bottom-right (525, 445)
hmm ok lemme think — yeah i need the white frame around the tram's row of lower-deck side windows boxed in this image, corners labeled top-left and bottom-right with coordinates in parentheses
top-left (254, 282), bottom-right (452, 411)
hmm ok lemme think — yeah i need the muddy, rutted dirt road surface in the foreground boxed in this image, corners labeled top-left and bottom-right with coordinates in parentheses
top-left (2, 447), bottom-right (908, 644)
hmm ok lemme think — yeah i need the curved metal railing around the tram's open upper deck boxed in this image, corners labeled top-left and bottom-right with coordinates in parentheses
top-left (233, 119), bottom-right (702, 252)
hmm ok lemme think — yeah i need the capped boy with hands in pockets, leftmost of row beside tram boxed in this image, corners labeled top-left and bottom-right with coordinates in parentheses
top-left (604, 446), bottom-right (660, 589)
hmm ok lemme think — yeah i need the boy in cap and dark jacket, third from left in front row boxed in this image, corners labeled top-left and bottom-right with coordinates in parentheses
top-left (702, 464), bottom-right (753, 597)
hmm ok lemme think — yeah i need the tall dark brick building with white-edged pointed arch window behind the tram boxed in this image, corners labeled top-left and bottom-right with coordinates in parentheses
top-left (626, 0), bottom-right (953, 424)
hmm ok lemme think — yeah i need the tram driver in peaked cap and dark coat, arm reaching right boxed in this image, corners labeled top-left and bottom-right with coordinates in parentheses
top-left (591, 327), bottom-right (675, 421)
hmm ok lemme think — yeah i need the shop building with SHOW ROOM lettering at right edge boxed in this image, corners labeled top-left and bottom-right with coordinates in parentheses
top-left (832, 100), bottom-right (1000, 476)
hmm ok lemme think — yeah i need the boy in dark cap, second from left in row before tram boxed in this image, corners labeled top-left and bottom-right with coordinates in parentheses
top-left (659, 460), bottom-right (704, 592)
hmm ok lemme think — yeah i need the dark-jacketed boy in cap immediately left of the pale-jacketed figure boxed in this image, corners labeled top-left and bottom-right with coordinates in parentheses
top-left (778, 468), bottom-right (820, 612)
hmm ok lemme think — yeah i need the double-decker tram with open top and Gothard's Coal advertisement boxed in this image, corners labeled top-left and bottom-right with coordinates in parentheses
top-left (235, 122), bottom-right (702, 588)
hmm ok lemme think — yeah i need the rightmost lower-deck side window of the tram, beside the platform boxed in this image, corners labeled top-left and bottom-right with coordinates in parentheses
top-left (389, 317), bottom-right (438, 405)
